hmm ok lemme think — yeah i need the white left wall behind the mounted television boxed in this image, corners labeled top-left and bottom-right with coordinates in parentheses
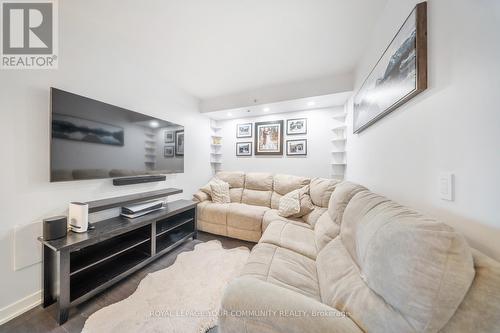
top-left (0, 1), bottom-right (211, 321)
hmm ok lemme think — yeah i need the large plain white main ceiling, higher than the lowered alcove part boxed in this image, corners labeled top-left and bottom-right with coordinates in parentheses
top-left (114, 0), bottom-right (386, 99)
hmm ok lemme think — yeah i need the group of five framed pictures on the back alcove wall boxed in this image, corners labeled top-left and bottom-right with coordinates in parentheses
top-left (235, 118), bottom-right (307, 157)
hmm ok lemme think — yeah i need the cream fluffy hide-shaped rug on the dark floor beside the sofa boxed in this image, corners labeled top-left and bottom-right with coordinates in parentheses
top-left (82, 241), bottom-right (249, 333)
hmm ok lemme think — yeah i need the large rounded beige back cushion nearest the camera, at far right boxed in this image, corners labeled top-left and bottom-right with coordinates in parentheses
top-left (330, 191), bottom-right (475, 332)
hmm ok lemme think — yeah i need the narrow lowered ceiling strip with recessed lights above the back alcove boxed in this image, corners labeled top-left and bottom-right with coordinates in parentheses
top-left (204, 91), bottom-right (352, 120)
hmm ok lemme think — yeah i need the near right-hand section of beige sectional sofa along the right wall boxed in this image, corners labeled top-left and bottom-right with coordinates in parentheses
top-left (192, 174), bottom-right (500, 333)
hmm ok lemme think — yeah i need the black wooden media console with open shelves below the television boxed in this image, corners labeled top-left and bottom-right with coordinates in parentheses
top-left (39, 189), bottom-right (196, 324)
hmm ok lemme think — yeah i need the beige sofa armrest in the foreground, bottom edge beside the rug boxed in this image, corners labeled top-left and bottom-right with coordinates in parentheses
top-left (219, 277), bottom-right (363, 333)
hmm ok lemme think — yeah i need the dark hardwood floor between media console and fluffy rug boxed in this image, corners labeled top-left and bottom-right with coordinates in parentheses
top-left (0, 232), bottom-right (254, 333)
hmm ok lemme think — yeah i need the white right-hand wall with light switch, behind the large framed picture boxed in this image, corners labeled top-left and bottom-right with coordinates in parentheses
top-left (347, 0), bottom-right (500, 259)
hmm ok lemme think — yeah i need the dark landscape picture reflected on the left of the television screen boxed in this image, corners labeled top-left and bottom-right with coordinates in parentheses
top-left (52, 113), bottom-right (125, 146)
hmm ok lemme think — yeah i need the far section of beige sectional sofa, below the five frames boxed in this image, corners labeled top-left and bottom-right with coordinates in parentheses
top-left (194, 172), bottom-right (338, 242)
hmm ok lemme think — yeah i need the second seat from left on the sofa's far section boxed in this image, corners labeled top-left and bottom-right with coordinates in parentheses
top-left (227, 203), bottom-right (269, 232)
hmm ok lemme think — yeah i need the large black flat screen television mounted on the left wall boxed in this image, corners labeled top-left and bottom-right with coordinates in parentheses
top-left (50, 88), bottom-right (184, 182)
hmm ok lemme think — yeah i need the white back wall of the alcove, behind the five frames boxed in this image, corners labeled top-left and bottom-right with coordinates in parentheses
top-left (218, 107), bottom-right (343, 178)
